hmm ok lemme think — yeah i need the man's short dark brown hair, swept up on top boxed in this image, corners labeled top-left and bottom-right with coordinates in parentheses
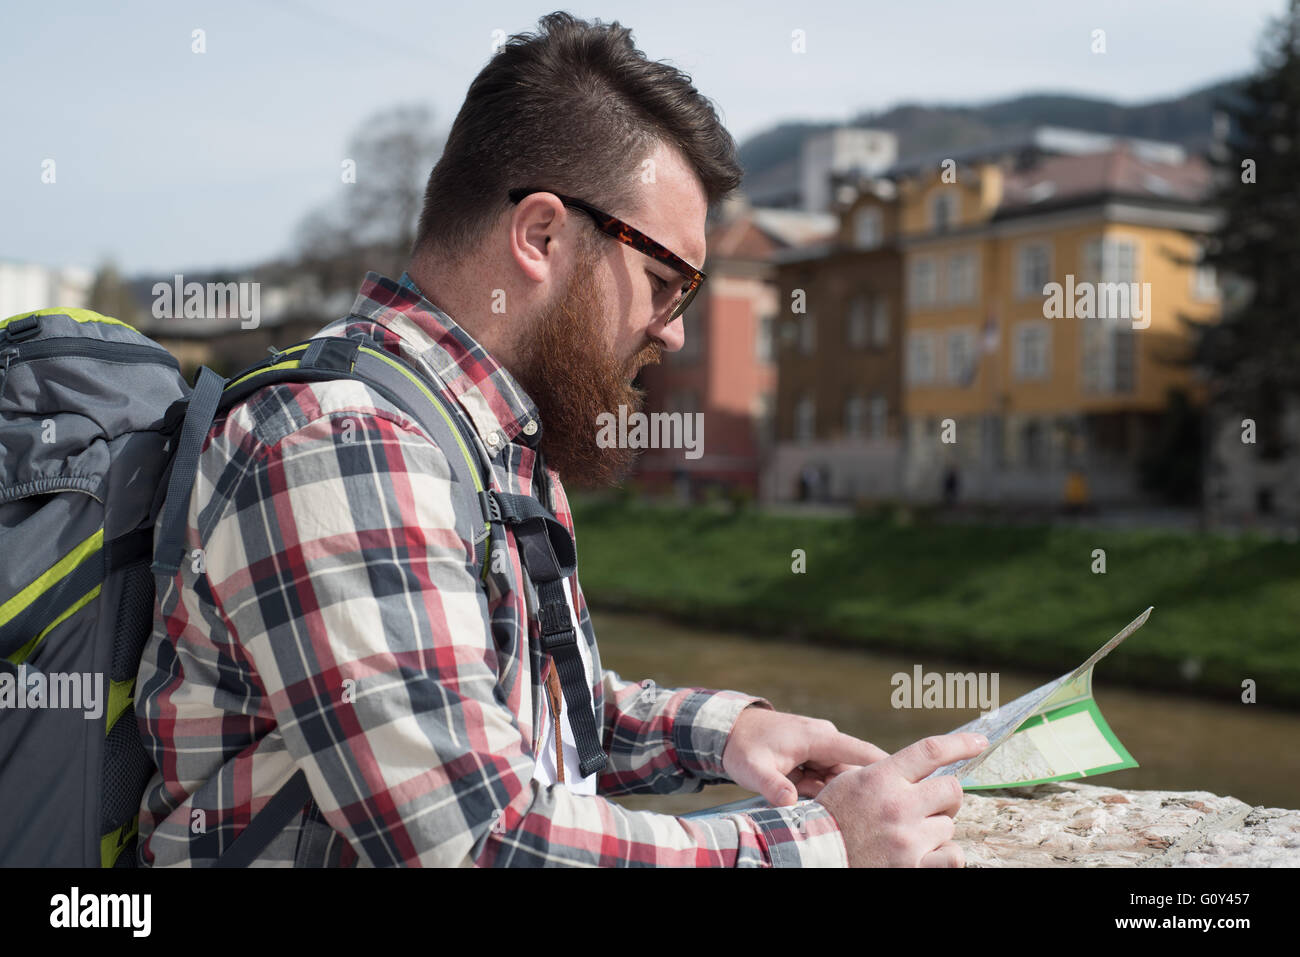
top-left (411, 12), bottom-right (742, 263)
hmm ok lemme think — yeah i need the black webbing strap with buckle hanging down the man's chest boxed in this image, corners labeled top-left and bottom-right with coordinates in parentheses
top-left (489, 492), bottom-right (606, 778)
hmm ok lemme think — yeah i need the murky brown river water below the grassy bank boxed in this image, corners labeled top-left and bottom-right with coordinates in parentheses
top-left (592, 612), bottom-right (1300, 814)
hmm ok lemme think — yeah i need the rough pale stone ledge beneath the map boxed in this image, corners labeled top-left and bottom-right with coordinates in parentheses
top-left (954, 781), bottom-right (1300, 867)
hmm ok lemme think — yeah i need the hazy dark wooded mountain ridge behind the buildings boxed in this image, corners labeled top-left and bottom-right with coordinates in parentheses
top-left (740, 79), bottom-right (1242, 178)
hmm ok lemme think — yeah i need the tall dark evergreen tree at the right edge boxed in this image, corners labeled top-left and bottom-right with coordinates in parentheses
top-left (1190, 0), bottom-right (1300, 452)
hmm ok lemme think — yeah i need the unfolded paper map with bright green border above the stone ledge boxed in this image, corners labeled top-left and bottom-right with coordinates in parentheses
top-left (683, 609), bottom-right (1152, 818)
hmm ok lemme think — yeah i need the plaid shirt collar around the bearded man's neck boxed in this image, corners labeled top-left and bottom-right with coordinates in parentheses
top-left (351, 272), bottom-right (542, 456)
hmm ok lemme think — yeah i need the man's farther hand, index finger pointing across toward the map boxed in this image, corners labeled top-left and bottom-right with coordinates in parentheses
top-left (723, 705), bottom-right (889, 807)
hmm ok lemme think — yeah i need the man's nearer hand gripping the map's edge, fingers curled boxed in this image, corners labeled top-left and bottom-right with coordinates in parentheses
top-left (815, 733), bottom-right (988, 867)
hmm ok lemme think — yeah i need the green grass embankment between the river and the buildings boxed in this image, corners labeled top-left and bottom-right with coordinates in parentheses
top-left (573, 502), bottom-right (1300, 709)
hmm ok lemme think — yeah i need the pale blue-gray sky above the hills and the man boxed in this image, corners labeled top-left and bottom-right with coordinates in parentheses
top-left (0, 0), bottom-right (1286, 274)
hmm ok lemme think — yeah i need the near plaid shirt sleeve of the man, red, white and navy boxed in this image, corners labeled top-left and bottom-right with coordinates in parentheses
top-left (199, 411), bottom-right (844, 866)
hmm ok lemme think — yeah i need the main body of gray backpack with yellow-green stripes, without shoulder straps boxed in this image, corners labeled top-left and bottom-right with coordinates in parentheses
top-left (0, 309), bottom-right (190, 867)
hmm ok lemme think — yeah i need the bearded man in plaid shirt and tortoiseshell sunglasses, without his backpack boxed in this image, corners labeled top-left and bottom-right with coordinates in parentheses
top-left (137, 13), bottom-right (980, 866)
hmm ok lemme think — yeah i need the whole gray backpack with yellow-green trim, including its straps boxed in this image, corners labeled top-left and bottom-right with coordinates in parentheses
top-left (0, 309), bottom-right (606, 867)
